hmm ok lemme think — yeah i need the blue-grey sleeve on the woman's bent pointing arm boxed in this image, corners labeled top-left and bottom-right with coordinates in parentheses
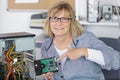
top-left (87, 33), bottom-right (120, 70)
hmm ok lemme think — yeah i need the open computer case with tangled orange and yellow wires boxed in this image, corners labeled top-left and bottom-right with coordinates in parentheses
top-left (0, 32), bottom-right (35, 80)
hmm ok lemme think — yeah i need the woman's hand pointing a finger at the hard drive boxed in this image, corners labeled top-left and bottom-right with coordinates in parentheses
top-left (57, 48), bottom-right (88, 61)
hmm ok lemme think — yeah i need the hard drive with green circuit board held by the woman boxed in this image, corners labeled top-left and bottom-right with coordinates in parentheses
top-left (34, 57), bottom-right (58, 75)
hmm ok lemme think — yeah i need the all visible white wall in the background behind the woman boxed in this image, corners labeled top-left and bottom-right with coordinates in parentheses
top-left (0, 0), bottom-right (120, 38)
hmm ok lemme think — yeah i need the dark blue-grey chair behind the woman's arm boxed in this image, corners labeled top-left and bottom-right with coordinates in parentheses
top-left (99, 37), bottom-right (120, 80)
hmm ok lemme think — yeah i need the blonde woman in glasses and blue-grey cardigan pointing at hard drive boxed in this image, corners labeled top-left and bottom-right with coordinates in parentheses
top-left (41, 2), bottom-right (120, 80)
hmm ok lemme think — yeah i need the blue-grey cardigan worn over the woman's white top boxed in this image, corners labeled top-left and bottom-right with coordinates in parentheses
top-left (41, 31), bottom-right (120, 80)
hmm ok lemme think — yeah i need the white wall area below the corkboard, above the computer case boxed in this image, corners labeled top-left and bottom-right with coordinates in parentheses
top-left (0, 0), bottom-right (42, 35)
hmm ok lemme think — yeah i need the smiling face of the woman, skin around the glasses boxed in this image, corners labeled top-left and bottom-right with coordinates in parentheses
top-left (50, 9), bottom-right (71, 37)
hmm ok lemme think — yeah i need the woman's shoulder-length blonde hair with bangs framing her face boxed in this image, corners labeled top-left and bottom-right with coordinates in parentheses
top-left (43, 1), bottom-right (83, 37)
